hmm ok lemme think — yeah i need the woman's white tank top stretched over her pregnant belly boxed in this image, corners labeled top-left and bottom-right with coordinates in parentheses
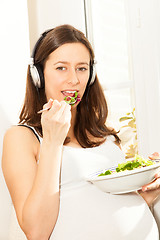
top-left (8, 126), bottom-right (159, 240)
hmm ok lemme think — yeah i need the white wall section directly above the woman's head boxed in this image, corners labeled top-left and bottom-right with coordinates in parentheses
top-left (28, 0), bottom-right (85, 53)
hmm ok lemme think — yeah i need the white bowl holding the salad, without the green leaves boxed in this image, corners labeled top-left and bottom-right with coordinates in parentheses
top-left (86, 161), bottom-right (160, 194)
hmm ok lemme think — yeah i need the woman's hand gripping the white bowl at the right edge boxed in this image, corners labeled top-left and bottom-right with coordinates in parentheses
top-left (138, 152), bottom-right (160, 206)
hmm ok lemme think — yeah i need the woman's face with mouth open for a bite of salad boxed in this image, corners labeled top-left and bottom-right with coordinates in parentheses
top-left (44, 43), bottom-right (90, 107)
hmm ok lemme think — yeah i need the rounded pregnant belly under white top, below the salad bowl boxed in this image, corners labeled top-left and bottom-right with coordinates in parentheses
top-left (50, 184), bottom-right (159, 240)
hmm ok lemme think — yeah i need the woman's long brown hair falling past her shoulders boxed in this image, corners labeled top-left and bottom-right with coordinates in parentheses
top-left (19, 25), bottom-right (120, 148)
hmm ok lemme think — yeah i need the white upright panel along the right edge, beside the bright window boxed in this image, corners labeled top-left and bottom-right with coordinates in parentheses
top-left (126, 0), bottom-right (160, 156)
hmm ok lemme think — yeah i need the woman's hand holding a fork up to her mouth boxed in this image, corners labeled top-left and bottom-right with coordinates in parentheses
top-left (41, 99), bottom-right (71, 145)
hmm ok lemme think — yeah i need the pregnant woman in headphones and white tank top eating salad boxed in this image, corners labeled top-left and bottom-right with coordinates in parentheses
top-left (2, 25), bottom-right (158, 240)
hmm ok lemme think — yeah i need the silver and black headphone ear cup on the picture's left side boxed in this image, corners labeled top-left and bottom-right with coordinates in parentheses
top-left (30, 64), bottom-right (44, 88)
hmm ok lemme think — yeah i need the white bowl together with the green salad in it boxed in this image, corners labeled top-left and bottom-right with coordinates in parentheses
top-left (87, 155), bottom-right (160, 194)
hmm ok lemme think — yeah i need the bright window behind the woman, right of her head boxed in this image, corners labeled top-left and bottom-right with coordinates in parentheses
top-left (84, 0), bottom-right (134, 130)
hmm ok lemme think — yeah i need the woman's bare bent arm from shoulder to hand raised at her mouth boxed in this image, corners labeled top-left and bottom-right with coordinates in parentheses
top-left (2, 100), bottom-right (71, 240)
